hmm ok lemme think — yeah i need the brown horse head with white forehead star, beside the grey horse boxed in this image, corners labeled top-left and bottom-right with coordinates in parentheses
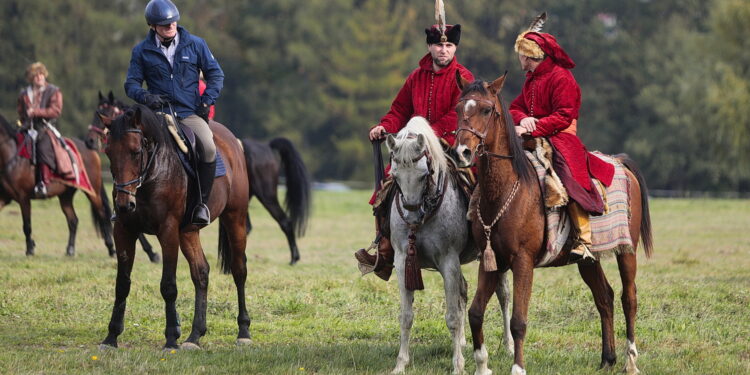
top-left (454, 72), bottom-right (515, 167)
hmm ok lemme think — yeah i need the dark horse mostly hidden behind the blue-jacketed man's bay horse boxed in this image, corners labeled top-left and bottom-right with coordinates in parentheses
top-left (86, 92), bottom-right (311, 265)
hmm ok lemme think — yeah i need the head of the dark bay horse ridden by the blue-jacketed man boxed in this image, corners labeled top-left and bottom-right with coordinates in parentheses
top-left (104, 105), bottom-right (164, 213)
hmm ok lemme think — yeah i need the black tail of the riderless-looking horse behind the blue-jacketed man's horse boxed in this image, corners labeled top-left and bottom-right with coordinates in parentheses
top-left (268, 137), bottom-right (310, 236)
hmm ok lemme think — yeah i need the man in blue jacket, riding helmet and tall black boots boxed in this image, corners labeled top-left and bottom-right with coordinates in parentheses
top-left (125, 0), bottom-right (224, 226)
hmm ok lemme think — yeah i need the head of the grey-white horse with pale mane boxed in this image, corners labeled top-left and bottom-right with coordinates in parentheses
top-left (386, 117), bottom-right (447, 216)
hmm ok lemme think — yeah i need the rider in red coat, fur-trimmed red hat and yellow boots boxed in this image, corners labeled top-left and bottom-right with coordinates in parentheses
top-left (510, 18), bottom-right (614, 262)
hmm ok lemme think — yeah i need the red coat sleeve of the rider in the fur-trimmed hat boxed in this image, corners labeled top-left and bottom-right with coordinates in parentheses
top-left (531, 70), bottom-right (581, 137)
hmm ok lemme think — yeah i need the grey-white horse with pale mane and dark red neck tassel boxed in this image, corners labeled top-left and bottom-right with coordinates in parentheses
top-left (386, 117), bottom-right (513, 374)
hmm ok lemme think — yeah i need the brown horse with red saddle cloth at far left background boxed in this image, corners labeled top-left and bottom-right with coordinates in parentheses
top-left (0, 116), bottom-right (115, 256)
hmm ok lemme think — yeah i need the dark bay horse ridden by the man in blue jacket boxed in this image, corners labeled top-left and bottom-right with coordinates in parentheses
top-left (101, 104), bottom-right (250, 348)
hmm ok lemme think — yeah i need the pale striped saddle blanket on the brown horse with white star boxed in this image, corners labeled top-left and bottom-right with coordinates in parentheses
top-left (526, 151), bottom-right (633, 267)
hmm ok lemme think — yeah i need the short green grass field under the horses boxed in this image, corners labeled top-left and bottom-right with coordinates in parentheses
top-left (0, 191), bottom-right (750, 374)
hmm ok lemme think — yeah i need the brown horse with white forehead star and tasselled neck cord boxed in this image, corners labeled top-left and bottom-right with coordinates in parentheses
top-left (454, 75), bottom-right (652, 375)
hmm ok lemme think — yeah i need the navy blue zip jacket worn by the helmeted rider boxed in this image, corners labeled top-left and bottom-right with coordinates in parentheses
top-left (125, 26), bottom-right (224, 118)
